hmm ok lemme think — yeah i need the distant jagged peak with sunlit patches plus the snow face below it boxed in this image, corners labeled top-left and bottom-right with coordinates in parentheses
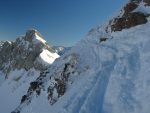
top-left (0, 30), bottom-right (59, 113)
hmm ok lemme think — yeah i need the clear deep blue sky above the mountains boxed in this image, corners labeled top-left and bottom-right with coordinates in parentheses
top-left (0, 0), bottom-right (128, 46)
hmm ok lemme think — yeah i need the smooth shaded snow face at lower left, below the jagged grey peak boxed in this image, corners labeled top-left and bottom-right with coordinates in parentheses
top-left (0, 69), bottom-right (40, 113)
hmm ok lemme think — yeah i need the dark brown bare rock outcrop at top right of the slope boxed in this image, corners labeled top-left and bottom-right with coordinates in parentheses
top-left (111, 0), bottom-right (149, 31)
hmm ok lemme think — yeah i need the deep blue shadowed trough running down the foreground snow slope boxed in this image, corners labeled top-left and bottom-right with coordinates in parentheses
top-left (55, 44), bottom-right (116, 113)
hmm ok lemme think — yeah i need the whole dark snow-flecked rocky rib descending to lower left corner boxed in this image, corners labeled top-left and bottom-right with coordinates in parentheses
top-left (11, 54), bottom-right (80, 113)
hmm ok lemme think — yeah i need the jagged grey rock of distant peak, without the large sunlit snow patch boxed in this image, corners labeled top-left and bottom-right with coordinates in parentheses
top-left (0, 30), bottom-right (56, 75)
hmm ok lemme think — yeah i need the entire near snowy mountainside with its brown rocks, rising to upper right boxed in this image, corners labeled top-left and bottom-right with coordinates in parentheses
top-left (0, 0), bottom-right (150, 113)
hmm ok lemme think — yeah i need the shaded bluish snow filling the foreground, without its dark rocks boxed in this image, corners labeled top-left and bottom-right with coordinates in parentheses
top-left (0, 0), bottom-right (150, 113)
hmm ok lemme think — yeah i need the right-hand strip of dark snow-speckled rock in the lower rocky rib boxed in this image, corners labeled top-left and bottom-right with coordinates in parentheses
top-left (47, 54), bottom-right (78, 105)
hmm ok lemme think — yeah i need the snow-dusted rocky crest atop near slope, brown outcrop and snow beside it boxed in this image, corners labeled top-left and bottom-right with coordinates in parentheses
top-left (87, 0), bottom-right (150, 43)
